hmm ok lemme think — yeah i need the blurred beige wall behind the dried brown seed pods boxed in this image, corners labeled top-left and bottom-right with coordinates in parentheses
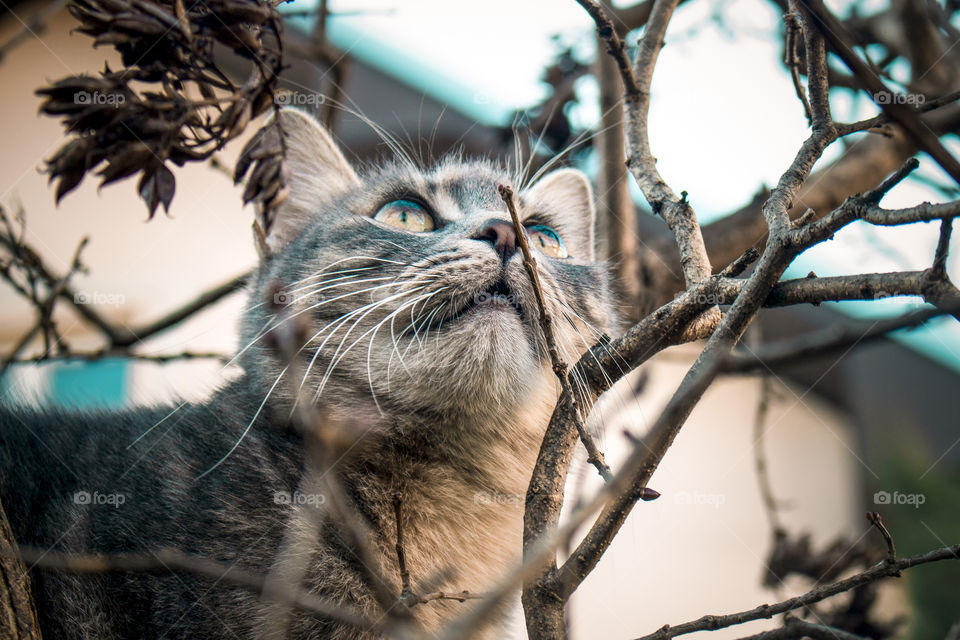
top-left (0, 0), bottom-right (254, 360)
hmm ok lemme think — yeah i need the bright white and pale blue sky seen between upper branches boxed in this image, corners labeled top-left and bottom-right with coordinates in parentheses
top-left (297, 0), bottom-right (960, 370)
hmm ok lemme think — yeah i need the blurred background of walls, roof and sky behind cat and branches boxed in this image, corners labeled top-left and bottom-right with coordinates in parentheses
top-left (0, 0), bottom-right (960, 638)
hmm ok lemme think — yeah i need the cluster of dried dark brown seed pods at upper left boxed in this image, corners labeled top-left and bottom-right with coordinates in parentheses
top-left (37, 0), bottom-right (286, 217)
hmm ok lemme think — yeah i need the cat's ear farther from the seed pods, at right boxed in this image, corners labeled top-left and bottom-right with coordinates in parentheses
top-left (524, 169), bottom-right (597, 260)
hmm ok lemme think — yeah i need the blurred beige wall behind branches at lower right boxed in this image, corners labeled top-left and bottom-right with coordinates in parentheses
top-left (572, 345), bottom-right (903, 640)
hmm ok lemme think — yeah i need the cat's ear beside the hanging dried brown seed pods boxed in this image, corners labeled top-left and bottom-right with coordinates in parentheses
top-left (255, 107), bottom-right (360, 258)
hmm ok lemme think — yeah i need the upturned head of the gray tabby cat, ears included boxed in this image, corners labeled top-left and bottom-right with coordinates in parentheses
top-left (245, 110), bottom-right (613, 414)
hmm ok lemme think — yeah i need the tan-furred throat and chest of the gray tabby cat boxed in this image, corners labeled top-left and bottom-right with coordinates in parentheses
top-left (308, 369), bottom-right (557, 630)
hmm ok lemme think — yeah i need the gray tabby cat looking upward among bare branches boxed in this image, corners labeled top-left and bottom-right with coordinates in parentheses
top-left (0, 110), bottom-right (614, 639)
